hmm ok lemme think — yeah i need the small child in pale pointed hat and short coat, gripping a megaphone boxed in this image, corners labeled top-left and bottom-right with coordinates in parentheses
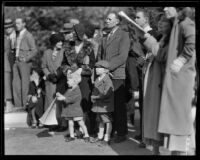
top-left (56, 68), bottom-right (89, 142)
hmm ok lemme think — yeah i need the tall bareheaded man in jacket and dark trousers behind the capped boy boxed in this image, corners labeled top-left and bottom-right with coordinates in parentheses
top-left (101, 13), bottom-right (130, 143)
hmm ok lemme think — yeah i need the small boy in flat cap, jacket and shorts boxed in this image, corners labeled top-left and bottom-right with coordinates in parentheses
top-left (91, 61), bottom-right (114, 145)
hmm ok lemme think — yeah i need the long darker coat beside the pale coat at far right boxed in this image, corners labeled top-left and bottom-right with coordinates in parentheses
top-left (143, 40), bottom-right (168, 141)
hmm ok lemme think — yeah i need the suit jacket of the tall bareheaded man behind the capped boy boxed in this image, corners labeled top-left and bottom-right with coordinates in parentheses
top-left (101, 27), bottom-right (130, 79)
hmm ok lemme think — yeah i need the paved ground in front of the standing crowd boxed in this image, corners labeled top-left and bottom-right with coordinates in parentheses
top-left (5, 110), bottom-right (168, 155)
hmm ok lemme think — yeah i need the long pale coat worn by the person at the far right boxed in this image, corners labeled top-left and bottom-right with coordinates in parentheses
top-left (158, 18), bottom-right (196, 136)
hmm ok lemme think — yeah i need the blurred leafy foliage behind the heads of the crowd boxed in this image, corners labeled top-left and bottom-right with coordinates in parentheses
top-left (4, 6), bottom-right (194, 64)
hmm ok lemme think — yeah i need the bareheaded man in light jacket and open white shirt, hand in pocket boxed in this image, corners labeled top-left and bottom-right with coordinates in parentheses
top-left (13, 17), bottom-right (37, 108)
